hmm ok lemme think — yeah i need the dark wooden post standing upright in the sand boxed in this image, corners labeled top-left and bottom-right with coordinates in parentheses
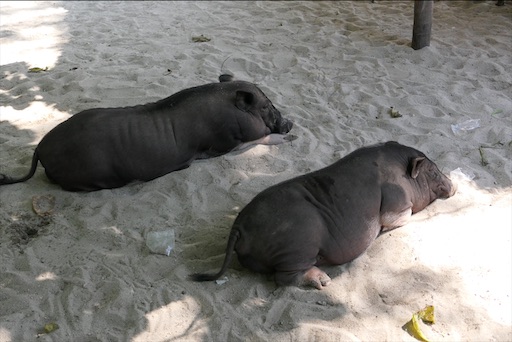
top-left (411, 0), bottom-right (433, 50)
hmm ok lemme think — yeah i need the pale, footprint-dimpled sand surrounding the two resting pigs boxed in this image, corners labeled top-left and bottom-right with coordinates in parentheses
top-left (0, 1), bottom-right (512, 341)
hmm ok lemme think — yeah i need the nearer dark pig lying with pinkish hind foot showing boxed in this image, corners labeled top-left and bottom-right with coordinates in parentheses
top-left (191, 142), bottom-right (455, 289)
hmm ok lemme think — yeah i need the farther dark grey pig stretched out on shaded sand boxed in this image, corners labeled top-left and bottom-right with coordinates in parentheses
top-left (0, 75), bottom-right (292, 191)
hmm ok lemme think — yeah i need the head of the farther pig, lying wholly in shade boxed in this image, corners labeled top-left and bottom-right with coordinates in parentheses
top-left (236, 89), bottom-right (293, 134)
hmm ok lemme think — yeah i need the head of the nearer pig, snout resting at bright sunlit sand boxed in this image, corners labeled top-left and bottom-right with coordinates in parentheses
top-left (407, 156), bottom-right (456, 212)
